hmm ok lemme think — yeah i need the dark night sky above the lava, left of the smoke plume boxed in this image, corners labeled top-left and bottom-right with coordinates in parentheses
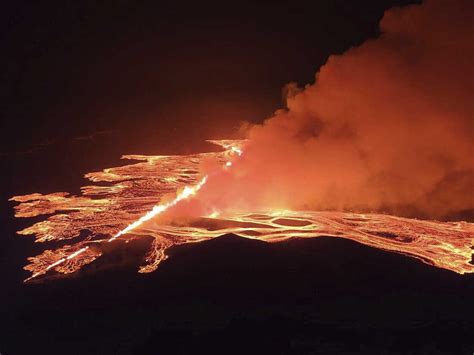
top-left (0, 0), bottom-right (416, 155)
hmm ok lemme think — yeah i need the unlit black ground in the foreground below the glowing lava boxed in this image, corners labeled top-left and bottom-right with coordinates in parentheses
top-left (0, 235), bottom-right (474, 355)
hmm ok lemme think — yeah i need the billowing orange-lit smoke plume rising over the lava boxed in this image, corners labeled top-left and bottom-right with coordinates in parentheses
top-left (201, 0), bottom-right (474, 218)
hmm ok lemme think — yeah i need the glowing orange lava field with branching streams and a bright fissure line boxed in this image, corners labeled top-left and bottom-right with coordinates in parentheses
top-left (11, 140), bottom-right (474, 280)
